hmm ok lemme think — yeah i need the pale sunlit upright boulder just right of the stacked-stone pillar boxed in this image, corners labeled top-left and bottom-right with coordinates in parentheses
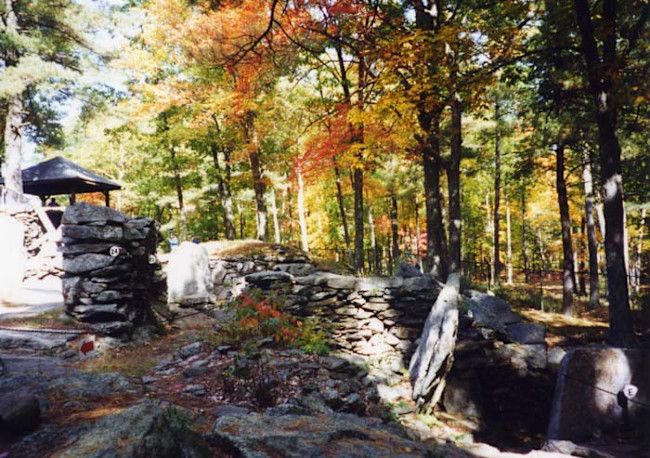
top-left (166, 242), bottom-right (212, 304)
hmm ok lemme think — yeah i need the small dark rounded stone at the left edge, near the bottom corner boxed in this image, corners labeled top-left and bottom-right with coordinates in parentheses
top-left (0, 391), bottom-right (41, 434)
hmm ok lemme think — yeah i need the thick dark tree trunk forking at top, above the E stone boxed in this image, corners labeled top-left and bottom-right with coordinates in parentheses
top-left (573, 0), bottom-right (632, 347)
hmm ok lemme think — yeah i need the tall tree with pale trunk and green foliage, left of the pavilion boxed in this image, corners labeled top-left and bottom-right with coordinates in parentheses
top-left (0, 0), bottom-right (90, 202)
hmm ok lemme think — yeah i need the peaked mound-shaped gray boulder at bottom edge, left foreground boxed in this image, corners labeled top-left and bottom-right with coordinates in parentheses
top-left (55, 402), bottom-right (212, 458)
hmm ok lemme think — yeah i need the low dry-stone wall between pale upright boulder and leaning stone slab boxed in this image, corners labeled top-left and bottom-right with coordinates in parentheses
top-left (212, 256), bottom-right (440, 367)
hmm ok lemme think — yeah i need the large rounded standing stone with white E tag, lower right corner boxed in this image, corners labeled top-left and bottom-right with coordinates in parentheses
top-left (548, 348), bottom-right (650, 443)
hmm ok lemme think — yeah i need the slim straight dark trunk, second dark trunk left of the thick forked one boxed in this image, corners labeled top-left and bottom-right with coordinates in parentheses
top-left (555, 143), bottom-right (575, 316)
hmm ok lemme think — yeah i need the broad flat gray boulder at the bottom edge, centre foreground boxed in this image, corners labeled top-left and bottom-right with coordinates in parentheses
top-left (211, 414), bottom-right (433, 458)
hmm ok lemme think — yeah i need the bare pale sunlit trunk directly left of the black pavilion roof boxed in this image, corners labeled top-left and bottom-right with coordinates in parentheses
top-left (2, 95), bottom-right (23, 205)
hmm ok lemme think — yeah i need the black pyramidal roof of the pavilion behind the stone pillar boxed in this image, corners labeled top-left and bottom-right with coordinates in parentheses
top-left (0, 157), bottom-right (122, 197)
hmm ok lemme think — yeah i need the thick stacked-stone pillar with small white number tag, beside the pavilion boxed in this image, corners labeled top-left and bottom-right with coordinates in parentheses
top-left (60, 203), bottom-right (167, 336)
